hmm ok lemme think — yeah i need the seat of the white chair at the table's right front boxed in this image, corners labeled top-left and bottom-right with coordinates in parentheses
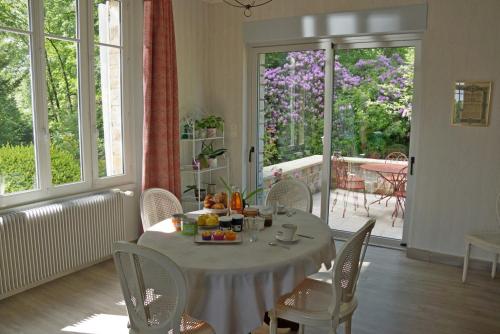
top-left (276, 278), bottom-right (358, 322)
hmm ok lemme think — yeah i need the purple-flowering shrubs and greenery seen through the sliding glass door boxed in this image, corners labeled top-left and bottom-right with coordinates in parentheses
top-left (262, 48), bottom-right (413, 166)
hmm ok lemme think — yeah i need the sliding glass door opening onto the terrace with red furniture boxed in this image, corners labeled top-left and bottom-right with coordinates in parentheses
top-left (247, 41), bottom-right (418, 245)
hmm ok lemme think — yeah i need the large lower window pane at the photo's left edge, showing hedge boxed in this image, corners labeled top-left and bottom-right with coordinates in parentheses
top-left (0, 32), bottom-right (36, 194)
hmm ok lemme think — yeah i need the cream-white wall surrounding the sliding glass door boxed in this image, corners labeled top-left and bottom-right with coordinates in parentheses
top-left (190, 0), bottom-right (500, 255)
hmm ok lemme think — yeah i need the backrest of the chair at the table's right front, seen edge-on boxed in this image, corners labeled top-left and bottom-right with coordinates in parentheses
top-left (330, 218), bottom-right (375, 320)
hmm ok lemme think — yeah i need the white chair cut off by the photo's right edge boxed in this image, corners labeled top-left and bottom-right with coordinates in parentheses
top-left (462, 193), bottom-right (500, 283)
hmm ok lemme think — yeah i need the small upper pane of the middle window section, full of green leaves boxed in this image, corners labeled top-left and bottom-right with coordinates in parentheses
top-left (45, 0), bottom-right (77, 38)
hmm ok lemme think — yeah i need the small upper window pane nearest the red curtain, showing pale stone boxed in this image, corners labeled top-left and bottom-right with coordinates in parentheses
top-left (94, 0), bottom-right (121, 45)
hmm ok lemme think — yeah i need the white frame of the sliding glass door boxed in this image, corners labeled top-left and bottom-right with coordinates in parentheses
top-left (242, 33), bottom-right (422, 247)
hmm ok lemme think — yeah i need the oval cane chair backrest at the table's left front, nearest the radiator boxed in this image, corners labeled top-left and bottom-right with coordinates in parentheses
top-left (113, 242), bottom-right (187, 334)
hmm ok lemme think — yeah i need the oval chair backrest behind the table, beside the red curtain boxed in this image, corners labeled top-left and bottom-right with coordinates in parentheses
top-left (141, 188), bottom-right (182, 231)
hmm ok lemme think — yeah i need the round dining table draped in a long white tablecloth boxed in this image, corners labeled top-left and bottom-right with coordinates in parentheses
top-left (138, 210), bottom-right (335, 334)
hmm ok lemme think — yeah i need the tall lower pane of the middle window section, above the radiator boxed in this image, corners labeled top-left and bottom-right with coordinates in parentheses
top-left (45, 38), bottom-right (81, 185)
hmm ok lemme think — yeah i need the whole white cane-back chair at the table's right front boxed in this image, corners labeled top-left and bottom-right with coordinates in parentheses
top-left (269, 218), bottom-right (375, 334)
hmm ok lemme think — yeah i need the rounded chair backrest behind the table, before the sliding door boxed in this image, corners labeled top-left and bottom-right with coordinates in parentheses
top-left (266, 179), bottom-right (312, 213)
